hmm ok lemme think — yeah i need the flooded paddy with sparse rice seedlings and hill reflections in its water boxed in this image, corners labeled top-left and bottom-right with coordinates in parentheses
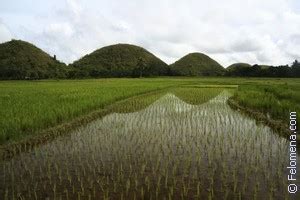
top-left (0, 87), bottom-right (300, 199)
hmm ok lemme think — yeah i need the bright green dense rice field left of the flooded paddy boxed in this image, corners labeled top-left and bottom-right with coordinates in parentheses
top-left (0, 79), bottom-right (183, 144)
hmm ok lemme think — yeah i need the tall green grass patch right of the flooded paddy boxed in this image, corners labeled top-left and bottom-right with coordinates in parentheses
top-left (233, 79), bottom-right (300, 124)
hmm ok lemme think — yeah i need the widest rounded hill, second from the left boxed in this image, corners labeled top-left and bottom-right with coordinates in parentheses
top-left (72, 44), bottom-right (169, 77)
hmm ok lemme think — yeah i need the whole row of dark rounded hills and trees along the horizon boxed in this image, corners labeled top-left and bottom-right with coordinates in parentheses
top-left (0, 40), bottom-right (300, 80)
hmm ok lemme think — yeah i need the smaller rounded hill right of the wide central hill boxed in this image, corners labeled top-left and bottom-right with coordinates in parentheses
top-left (170, 53), bottom-right (225, 76)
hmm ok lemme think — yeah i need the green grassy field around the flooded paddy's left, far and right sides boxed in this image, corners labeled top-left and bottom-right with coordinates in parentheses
top-left (0, 77), bottom-right (300, 144)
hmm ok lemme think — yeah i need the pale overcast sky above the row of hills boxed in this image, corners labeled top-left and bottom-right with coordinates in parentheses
top-left (0, 0), bottom-right (300, 67)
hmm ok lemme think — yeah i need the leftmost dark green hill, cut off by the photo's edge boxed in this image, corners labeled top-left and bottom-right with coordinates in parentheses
top-left (0, 40), bottom-right (67, 79)
